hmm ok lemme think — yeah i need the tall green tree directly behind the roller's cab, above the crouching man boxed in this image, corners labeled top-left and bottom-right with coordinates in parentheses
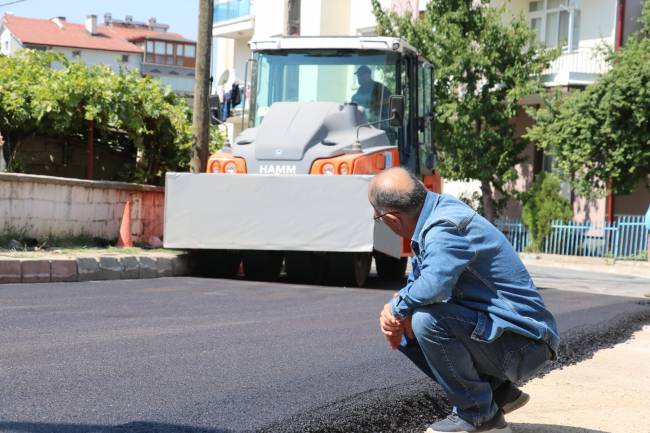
top-left (372, 0), bottom-right (557, 220)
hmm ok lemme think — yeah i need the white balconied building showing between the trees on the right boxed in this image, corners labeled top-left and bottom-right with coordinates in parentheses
top-left (491, 0), bottom-right (650, 221)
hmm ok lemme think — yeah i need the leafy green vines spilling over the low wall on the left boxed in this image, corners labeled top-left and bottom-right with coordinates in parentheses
top-left (0, 50), bottom-right (197, 183)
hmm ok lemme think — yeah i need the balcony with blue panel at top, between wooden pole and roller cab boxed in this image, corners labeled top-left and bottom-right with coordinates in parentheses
top-left (212, 0), bottom-right (254, 39)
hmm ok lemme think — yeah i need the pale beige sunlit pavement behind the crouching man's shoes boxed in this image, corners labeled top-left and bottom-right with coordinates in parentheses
top-left (507, 326), bottom-right (650, 433)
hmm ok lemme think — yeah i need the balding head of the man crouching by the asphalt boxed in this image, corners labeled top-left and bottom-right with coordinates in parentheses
top-left (368, 167), bottom-right (427, 217)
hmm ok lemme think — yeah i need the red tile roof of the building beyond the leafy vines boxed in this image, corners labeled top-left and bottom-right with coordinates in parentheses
top-left (3, 14), bottom-right (193, 53)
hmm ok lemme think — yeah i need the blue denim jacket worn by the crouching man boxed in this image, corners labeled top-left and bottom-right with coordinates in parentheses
top-left (391, 192), bottom-right (560, 352)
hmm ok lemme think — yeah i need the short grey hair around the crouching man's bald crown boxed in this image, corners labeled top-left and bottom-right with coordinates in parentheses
top-left (370, 170), bottom-right (427, 216)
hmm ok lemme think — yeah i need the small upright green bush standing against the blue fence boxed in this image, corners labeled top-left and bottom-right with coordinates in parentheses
top-left (522, 173), bottom-right (573, 252)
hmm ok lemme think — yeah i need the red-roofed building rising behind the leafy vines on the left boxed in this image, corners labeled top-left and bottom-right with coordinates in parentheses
top-left (0, 13), bottom-right (196, 97)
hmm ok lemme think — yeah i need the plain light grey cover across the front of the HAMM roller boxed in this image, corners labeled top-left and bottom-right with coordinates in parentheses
top-left (164, 173), bottom-right (400, 257)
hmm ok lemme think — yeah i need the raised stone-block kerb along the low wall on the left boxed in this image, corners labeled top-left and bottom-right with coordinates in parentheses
top-left (0, 248), bottom-right (188, 284)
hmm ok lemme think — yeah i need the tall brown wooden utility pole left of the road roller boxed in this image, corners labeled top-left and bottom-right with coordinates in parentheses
top-left (190, 0), bottom-right (214, 173)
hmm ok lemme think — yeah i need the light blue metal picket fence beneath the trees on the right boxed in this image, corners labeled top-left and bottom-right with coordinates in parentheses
top-left (495, 215), bottom-right (648, 260)
